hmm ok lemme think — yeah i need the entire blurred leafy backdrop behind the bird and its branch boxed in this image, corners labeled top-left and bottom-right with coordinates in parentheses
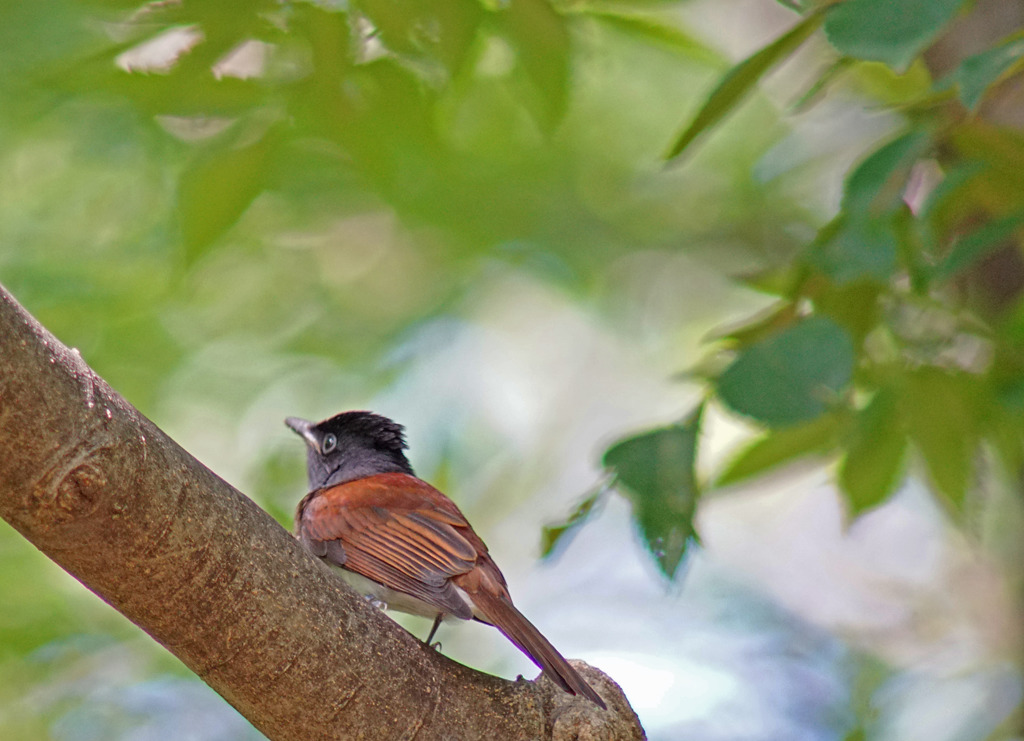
top-left (0, 0), bottom-right (1024, 741)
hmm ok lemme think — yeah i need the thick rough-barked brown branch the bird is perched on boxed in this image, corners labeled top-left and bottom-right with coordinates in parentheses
top-left (0, 287), bottom-right (643, 741)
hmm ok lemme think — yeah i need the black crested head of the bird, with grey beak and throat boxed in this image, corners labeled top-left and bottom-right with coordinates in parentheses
top-left (285, 411), bottom-right (413, 490)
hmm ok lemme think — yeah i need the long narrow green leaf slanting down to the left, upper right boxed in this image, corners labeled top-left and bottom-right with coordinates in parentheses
top-left (665, 12), bottom-right (821, 160)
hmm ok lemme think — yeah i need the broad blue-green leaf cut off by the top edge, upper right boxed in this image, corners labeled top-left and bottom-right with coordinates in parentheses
top-left (825, 0), bottom-right (964, 71)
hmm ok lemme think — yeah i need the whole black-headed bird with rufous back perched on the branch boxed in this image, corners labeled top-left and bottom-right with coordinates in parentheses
top-left (285, 411), bottom-right (606, 709)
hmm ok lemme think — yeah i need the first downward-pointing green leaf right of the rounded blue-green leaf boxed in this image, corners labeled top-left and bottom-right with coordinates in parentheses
top-left (839, 389), bottom-right (907, 517)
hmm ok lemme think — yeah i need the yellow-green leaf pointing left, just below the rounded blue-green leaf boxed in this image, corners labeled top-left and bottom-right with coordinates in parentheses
top-left (715, 415), bottom-right (846, 487)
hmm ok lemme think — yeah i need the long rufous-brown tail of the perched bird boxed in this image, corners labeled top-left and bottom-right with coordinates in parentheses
top-left (471, 590), bottom-right (607, 709)
